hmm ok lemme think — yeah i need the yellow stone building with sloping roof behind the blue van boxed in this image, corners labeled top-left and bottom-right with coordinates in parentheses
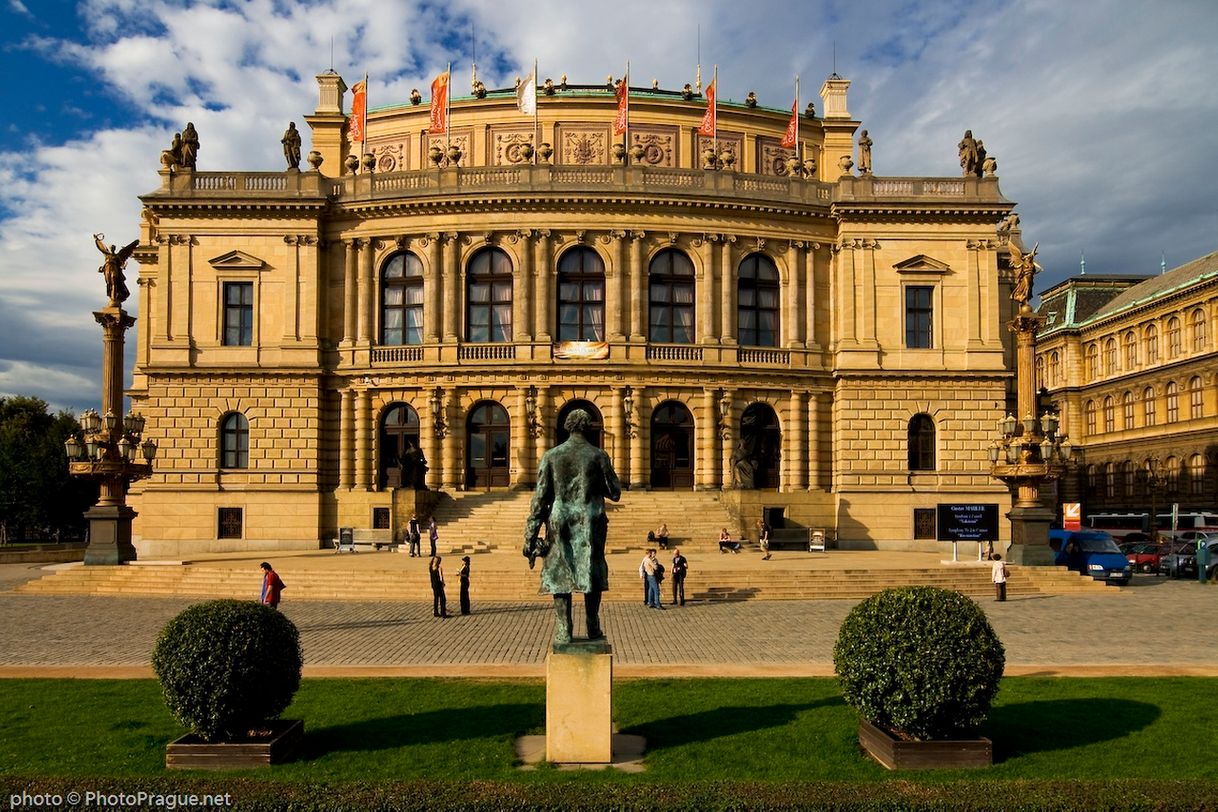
top-left (1037, 253), bottom-right (1218, 514)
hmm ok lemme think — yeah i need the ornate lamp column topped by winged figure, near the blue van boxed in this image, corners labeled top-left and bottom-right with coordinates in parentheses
top-left (989, 242), bottom-right (1072, 565)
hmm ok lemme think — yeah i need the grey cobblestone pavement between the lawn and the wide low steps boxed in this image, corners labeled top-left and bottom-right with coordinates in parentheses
top-left (0, 565), bottom-right (1218, 677)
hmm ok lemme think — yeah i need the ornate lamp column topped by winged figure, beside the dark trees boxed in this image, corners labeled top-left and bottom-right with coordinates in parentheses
top-left (63, 234), bottom-right (156, 565)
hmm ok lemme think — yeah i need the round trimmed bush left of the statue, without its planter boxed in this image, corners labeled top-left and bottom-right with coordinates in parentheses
top-left (152, 600), bottom-right (303, 741)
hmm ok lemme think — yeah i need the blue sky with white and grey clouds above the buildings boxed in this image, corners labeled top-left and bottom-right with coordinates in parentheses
top-left (0, 0), bottom-right (1218, 411)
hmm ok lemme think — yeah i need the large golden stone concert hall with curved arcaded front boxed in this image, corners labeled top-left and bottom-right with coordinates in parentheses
top-left (129, 72), bottom-right (1013, 555)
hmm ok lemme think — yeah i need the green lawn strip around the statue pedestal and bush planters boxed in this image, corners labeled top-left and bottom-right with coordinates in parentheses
top-left (0, 677), bottom-right (1218, 807)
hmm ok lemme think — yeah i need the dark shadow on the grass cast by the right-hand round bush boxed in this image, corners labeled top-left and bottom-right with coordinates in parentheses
top-left (984, 698), bottom-right (1162, 763)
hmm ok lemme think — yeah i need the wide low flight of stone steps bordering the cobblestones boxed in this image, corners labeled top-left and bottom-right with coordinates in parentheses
top-left (17, 553), bottom-right (1118, 601)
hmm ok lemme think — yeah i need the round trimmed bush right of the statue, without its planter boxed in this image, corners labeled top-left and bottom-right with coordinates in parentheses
top-left (833, 587), bottom-right (1006, 740)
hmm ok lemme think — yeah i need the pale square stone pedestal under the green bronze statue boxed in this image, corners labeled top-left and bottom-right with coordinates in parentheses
top-left (546, 640), bottom-right (613, 765)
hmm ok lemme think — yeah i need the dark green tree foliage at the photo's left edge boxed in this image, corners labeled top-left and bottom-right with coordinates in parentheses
top-left (0, 396), bottom-right (97, 541)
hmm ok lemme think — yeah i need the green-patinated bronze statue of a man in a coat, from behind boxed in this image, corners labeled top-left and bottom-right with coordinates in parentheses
top-left (524, 409), bottom-right (621, 644)
